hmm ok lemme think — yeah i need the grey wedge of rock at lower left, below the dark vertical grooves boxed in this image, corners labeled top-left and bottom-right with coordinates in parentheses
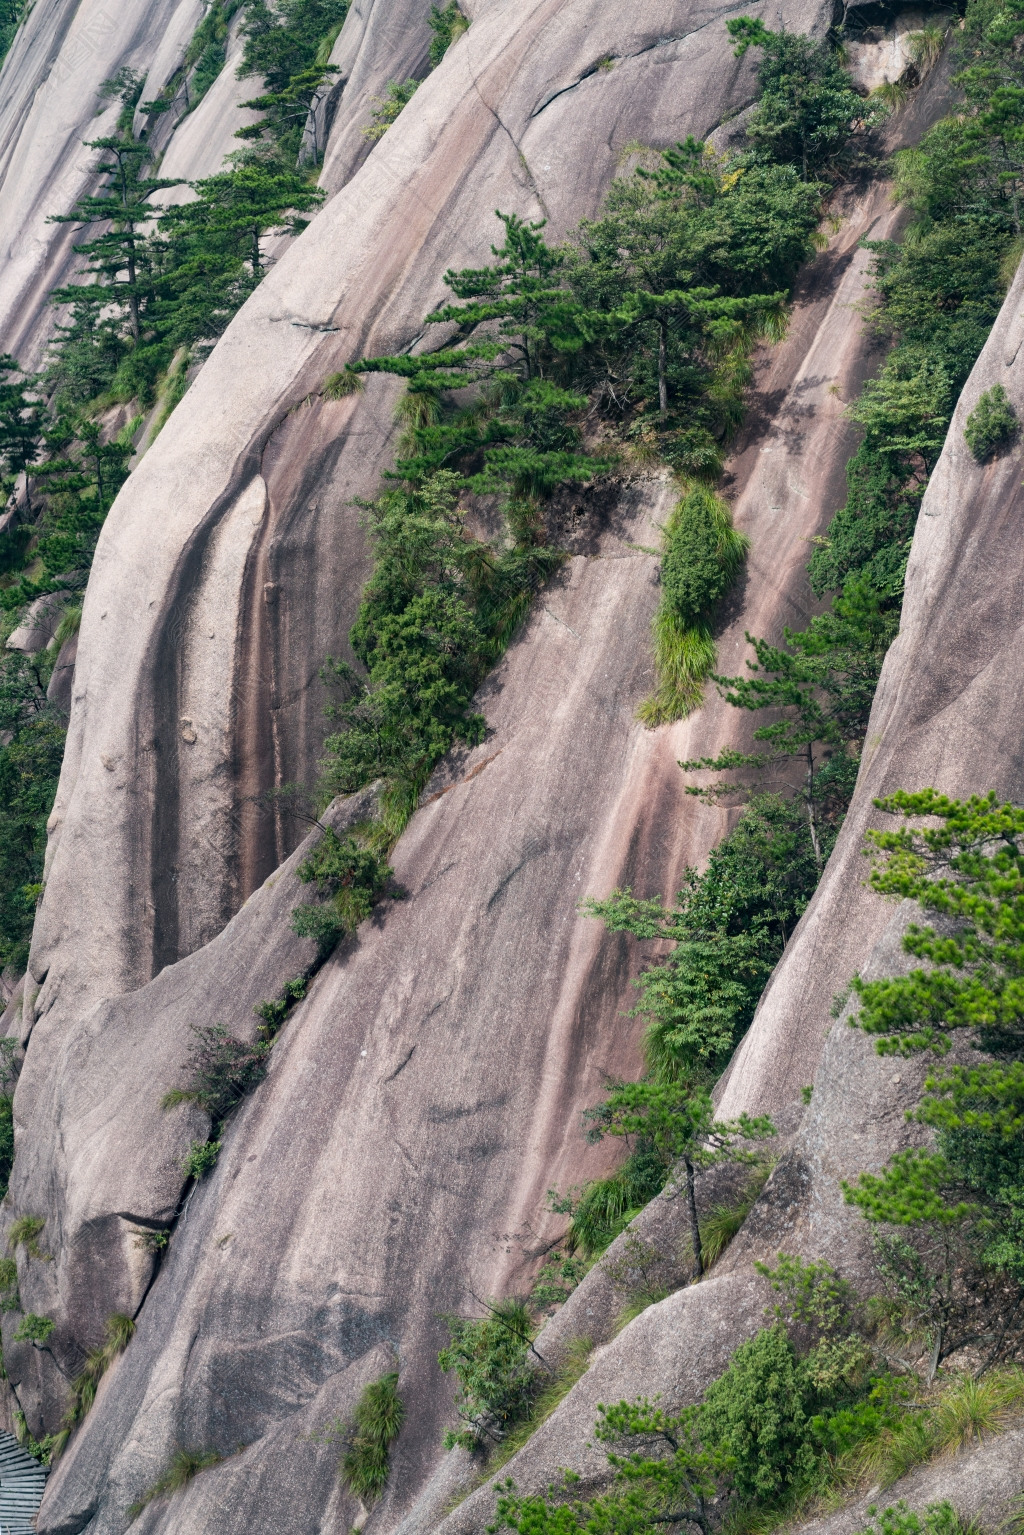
top-left (3, 789), bottom-right (375, 1434)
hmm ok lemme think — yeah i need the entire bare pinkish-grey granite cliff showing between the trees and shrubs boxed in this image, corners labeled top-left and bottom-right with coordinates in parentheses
top-left (0, 0), bottom-right (1024, 1535)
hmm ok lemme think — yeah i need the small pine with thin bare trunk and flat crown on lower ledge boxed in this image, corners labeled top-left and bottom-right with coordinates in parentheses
top-left (588, 1082), bottom-right (775, 1279)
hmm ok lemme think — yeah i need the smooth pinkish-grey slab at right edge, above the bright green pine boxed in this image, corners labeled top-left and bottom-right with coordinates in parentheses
top-left (722, 251), bottom-right (1024, 1114)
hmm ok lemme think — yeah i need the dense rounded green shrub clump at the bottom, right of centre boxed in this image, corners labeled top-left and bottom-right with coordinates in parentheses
top-left (493, 1256), bottom-right (901, 1535)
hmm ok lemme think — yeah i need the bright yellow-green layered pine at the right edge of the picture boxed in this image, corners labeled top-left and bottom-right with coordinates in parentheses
top-left (846, 789), bottom-right (1024, 1374)
